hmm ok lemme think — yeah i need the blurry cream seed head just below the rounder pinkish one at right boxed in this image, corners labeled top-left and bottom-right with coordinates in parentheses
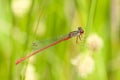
top-left (72, 55), bottom-right (94, 78)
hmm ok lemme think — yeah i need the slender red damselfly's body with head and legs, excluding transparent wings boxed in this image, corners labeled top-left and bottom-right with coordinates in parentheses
top-left (16, 27), bottom-right (84, 64)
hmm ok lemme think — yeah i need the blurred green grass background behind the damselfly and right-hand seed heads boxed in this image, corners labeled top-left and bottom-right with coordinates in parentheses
top-left (0, 0), bottom-right (120, 80)
